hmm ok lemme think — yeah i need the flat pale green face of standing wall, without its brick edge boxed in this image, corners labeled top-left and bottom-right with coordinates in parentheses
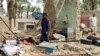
top-left (55, 0), bottom-right (77, 28)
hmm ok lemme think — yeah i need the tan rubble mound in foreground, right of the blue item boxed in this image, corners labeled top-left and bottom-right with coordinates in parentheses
top-left (52, 42), bottom-right (100, 56)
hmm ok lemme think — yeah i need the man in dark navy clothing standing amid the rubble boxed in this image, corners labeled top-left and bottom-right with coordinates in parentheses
top-left (40, 13), bottom-right (49, 42)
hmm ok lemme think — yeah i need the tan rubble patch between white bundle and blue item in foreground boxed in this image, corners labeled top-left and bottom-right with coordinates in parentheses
top-left (19, 44), bottom-right (47, 56)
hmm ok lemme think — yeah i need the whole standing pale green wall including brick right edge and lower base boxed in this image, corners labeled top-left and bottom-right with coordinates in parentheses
top-left (55, 0), bottom-right (80, 38)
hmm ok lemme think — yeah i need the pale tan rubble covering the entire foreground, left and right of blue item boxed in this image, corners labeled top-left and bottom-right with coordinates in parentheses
top-left (0, 36), bottom-right (100, 56)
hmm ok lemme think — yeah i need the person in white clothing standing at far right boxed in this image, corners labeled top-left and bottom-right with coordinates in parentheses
top-left (89, 14), bottom-right (97, 33)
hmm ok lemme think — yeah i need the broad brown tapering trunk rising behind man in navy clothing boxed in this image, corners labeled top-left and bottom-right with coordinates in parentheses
top-left (44, 0), bottom-right (56, 28)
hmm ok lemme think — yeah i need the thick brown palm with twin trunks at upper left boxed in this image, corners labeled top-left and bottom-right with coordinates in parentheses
top-left (7, 0), bottom-right (27, 28)
